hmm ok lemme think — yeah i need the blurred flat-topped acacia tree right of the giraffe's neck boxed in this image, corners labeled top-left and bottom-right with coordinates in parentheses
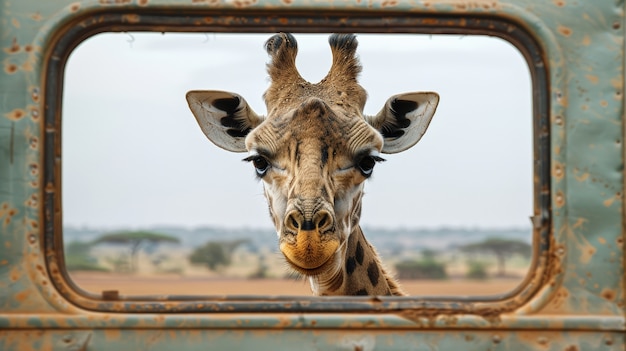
top-left (459, 238), bottom-right (532, 277)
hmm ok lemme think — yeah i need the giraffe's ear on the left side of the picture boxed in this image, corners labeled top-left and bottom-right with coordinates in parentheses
top-left (186, 90), bottom-right (263, 152)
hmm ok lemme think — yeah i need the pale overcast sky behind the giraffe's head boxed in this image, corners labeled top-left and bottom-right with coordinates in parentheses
top-left (62, 33), bottom-right (533, 229)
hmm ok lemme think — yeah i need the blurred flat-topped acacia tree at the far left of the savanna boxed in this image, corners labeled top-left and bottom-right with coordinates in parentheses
top-left (93, 231), bottom-right (180, 272)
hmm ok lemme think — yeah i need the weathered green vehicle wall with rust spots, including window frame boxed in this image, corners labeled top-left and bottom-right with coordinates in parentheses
top-left (0, 0), bottom-right (626, 350)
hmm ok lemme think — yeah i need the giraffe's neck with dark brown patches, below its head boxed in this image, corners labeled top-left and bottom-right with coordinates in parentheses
top-left (310, 225), bottom-right (405, 296)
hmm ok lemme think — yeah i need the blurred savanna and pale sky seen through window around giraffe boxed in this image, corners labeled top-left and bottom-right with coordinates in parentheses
top-left (62, 33), bottom-right (533, 295)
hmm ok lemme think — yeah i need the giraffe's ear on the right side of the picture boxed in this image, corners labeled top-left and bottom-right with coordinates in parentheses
top-left (366, 92), bottom-right (439, 154)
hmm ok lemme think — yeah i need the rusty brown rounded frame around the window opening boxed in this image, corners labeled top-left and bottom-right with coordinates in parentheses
top-left (43, 9), bottom-right (558, 314)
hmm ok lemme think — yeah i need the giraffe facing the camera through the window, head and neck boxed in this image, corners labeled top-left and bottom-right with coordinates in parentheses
top-left (186, 33), bottom-right (439, 296)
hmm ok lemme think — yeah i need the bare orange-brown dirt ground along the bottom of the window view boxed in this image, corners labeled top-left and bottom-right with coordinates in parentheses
top-left (71, 272), bottom-right (521, 296)
